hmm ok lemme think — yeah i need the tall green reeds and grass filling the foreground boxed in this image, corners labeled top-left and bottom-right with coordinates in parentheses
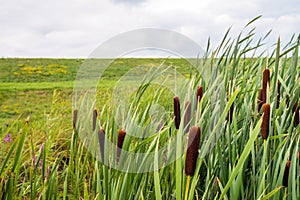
top-left (0, 20), bottom-right (300, 200)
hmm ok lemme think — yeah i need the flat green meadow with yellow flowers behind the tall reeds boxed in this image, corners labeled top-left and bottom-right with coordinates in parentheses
top-left (0, 58), bottom-right (190, 127)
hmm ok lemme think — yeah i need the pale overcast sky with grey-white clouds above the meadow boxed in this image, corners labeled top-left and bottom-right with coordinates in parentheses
top-left (0, 0), bottom-right (300, 58)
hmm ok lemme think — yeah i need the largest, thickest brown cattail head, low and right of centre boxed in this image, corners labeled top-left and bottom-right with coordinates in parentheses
top-left (185, 126), bottom-right (201, 176)
